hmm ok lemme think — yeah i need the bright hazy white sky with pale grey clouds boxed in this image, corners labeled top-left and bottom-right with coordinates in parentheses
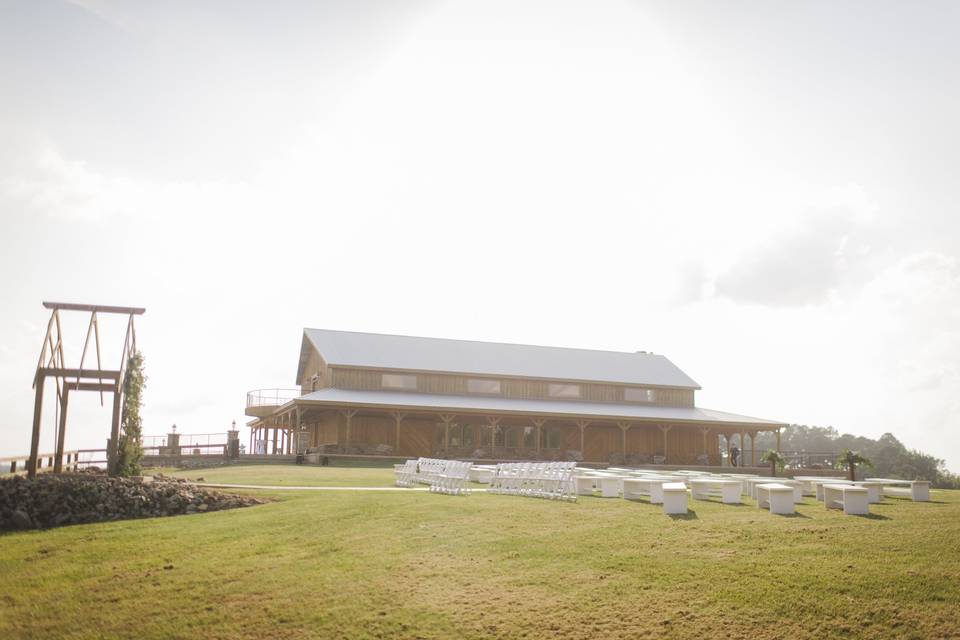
top-left (0, 0), bottom-right (960, 471)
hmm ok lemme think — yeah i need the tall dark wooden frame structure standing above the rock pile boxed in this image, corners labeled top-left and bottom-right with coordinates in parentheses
top-left (27, 302), bottom-right (146, 478)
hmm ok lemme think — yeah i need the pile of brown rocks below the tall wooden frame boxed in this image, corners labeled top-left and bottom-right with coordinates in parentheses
top-left (0, 473), bottom-right (263, 531)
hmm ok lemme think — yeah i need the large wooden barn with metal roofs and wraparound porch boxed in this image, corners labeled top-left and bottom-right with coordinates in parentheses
top-left (247, 329), bottom-right (786, 465)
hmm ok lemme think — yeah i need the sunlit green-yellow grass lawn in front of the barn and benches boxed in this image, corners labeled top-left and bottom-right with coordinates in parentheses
top-left (0, 467), bottom-right (960, 639)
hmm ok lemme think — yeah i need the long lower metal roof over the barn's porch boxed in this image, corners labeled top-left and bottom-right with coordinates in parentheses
top-left (288, 388), bottom-right (786, 429)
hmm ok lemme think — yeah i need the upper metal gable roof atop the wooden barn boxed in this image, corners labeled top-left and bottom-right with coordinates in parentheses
top-left (297, 329), bottom-right (700, 389)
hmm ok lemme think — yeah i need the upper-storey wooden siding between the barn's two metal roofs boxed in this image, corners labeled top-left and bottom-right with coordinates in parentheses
top-left (327, 367), bottom-right (694, 407)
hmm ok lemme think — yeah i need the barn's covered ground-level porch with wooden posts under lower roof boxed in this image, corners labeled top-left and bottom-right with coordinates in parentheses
top-left (248, 396), bottom-right (782, 467)
